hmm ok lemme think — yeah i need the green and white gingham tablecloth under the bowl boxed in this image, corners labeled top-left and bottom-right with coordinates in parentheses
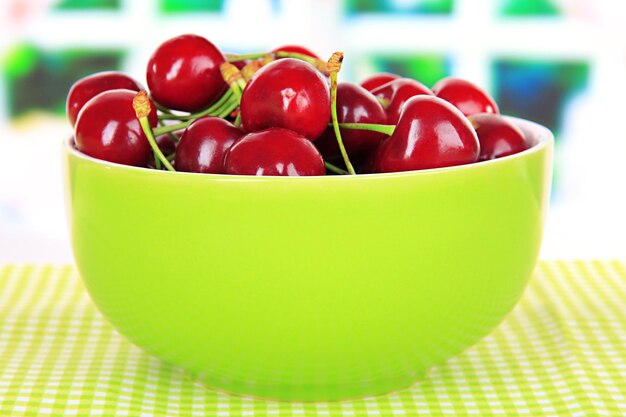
top-left (0, 261), bottom-right (626, 417)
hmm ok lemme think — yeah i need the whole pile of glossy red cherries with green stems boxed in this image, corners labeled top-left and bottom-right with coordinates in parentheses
top-left (67, 35), bottom-right (529, 176)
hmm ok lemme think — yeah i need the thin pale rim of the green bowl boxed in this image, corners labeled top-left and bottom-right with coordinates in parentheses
top-left (63, 115), bottom-right (554, 181)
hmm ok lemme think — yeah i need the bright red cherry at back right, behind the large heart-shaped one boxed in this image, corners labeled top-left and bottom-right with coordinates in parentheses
top-left (433, 77), bottom-right (500, 116)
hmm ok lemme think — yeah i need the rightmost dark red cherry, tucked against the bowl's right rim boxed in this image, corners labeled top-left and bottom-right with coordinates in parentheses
top-left (469, 113), bottom-right (528, 161)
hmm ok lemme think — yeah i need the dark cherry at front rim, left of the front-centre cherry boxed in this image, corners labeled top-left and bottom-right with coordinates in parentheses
top-left (176, 116), bottom-right (243, 174)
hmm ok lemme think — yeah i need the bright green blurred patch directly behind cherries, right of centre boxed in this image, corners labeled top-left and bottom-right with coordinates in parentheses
top-left (361, 53), bottom-right (450, 87)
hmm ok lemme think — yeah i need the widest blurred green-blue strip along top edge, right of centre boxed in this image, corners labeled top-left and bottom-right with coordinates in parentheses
top-left (344, 0), bottom-right (454, 15)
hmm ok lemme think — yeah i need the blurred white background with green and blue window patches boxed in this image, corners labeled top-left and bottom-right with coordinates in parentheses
top-left (0, 0), bottom-right (626, 262)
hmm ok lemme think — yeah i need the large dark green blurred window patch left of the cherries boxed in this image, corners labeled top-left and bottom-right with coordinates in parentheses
top-left (2, 44), bottom-right (125, 118)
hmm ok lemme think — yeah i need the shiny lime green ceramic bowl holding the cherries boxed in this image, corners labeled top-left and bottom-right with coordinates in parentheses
top-left (64, 119), bottom-right (553, 401)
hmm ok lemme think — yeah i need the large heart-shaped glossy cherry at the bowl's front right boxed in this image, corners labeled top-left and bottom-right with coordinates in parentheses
top-left (375, 95), bottom-right (480, 172)
